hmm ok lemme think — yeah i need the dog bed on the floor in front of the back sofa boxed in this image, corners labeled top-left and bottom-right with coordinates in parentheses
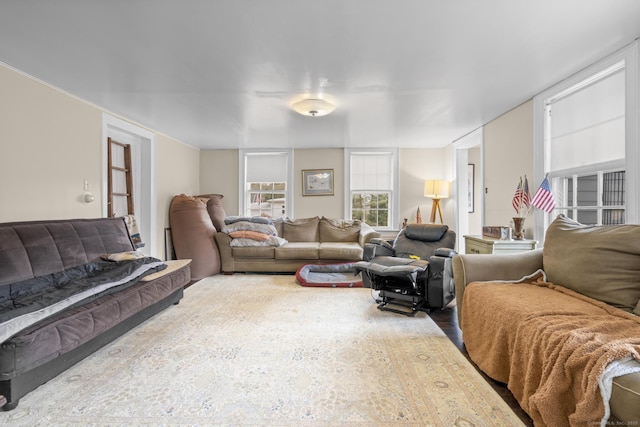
top-left (296, 262), bottom-right (362, 288)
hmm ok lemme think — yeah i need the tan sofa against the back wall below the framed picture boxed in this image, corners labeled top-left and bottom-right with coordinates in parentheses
top-left (215, 217), bottom-right (380, 274)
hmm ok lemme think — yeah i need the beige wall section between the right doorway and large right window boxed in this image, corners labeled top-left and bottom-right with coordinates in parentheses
top-left (483, 101), bottom-right (537, 238)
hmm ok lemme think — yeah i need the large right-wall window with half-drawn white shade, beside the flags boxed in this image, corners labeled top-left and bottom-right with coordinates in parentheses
top-left (546, 62), bottom-right (625, 225)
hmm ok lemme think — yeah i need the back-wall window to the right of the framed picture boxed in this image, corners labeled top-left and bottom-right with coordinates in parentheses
top-left (345, 150), bottom-right (397, 229)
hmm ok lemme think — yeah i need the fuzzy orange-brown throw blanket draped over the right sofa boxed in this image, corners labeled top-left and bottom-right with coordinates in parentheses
top-left (461, 271), bottom-right (640, 426)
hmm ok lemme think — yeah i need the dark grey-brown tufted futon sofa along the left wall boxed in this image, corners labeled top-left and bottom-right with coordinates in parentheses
top-left (0, 218), bottom-right (190, 410)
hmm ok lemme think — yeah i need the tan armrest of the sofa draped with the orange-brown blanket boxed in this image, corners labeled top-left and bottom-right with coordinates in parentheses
top-left (453, 249), bottom-right (542, 324)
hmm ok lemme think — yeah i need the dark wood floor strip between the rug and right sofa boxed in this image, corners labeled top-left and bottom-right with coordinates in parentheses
top-left (429, 305), bottom-right (533, 427)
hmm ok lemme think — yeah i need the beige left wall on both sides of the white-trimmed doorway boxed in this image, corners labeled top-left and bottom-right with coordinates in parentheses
top-left (0, 66), bottom-right (200, 257)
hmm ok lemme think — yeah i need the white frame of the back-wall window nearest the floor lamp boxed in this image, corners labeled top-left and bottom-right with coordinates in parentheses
top-left (344, 148), bottom-right (399, 231)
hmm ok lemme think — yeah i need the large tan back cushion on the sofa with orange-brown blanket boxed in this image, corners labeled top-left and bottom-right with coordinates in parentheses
top-left (542, 215), bottom-right (640, 312)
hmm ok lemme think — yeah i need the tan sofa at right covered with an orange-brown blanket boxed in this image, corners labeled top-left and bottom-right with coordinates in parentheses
top-left (453, 215), bottom-right (640, 426)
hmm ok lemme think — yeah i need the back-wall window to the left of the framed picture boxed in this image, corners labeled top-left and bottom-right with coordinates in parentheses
top-left (240, 151), bottom-right (291, 218)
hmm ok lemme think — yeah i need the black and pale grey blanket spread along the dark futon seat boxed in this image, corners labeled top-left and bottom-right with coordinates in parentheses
top-left (0, 257), bottom-right (166, 343)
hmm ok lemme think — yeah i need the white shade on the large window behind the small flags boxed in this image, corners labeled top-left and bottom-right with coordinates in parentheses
top-left (549, 70), bottom-right (625, 171)
